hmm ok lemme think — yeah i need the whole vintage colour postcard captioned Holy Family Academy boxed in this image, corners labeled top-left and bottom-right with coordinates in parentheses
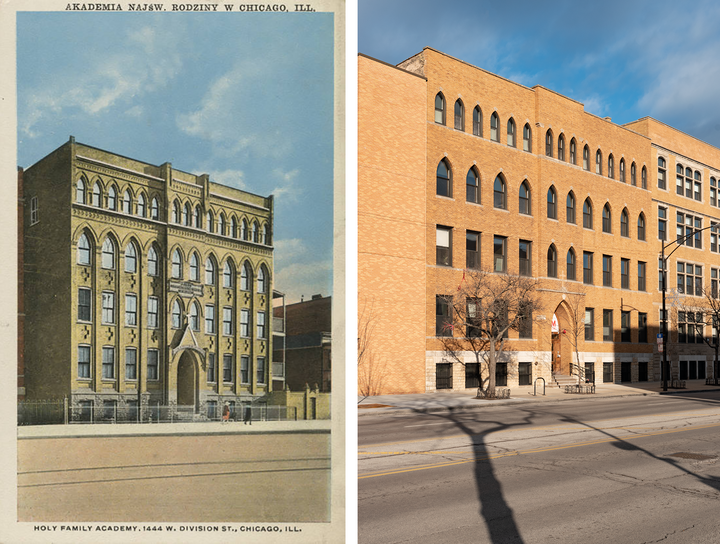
top-left (0, 0), bottom-right (346, 542)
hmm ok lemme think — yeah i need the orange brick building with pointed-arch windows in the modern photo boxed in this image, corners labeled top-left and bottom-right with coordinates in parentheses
top-left (358, 48), bottom-right (720, 394)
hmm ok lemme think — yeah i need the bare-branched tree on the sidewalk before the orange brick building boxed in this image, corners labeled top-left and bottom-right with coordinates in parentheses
top-left (436, 270), bottom-right (541, 398)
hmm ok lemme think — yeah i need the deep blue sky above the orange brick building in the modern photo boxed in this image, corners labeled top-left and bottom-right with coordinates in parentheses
top-left (358, 0), bottom-right (720, 147)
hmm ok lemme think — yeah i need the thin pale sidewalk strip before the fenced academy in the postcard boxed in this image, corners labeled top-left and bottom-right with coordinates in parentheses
top-left (18, 419), bottom-right (332, 440)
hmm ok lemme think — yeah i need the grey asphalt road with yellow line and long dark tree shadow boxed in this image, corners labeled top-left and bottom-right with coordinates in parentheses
top-left (359, 392), bottom-right (720, 544)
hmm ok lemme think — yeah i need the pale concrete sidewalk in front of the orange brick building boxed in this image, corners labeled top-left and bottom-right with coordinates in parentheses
top-left (358, 379), bottom-right (720, 417)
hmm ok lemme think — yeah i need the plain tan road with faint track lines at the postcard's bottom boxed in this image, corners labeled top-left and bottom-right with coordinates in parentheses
top-left (18, 434), bottom-right (330, 522)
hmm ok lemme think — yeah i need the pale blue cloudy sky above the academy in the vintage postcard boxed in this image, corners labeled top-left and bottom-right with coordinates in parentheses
top-left (17, 12), bottom-right (333, 302)
